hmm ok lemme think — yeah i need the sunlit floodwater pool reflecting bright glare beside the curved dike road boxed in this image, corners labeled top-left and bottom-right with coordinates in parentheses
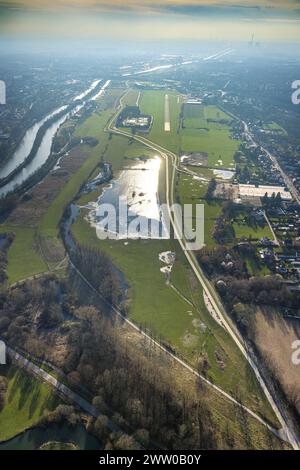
top-left (88, 157), bottom-right (169, 239)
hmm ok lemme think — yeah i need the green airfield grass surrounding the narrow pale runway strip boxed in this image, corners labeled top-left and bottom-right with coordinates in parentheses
top-left (129, 90), bottom-right (240, 168)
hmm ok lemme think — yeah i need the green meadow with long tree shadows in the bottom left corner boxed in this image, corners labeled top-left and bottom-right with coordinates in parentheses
top-left (0, 366), bottom-right (59, 441)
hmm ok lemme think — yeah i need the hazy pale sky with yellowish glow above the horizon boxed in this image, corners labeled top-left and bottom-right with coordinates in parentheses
top-left (0, 0), bottom-right (300, 42)
